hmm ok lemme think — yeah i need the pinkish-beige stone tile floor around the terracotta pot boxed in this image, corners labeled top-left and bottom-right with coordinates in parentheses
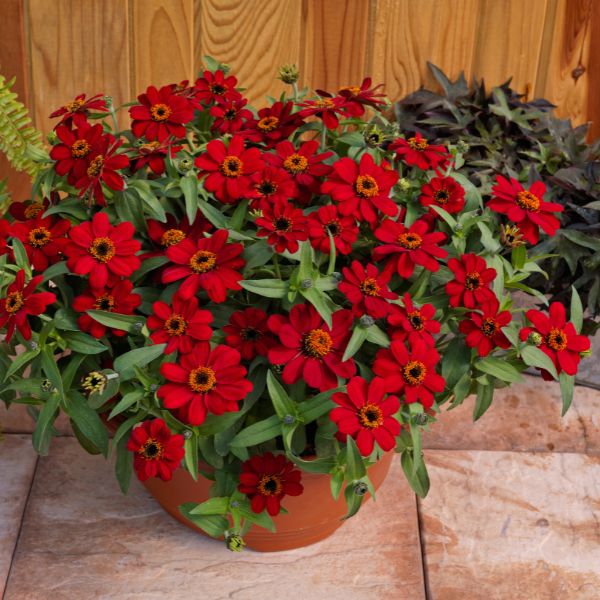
top-left (0, 376), bottom-right (600, 600)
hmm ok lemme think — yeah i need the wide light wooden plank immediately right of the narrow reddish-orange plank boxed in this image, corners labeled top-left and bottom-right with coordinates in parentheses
top-left (366, 0), bottom-right (479, 101)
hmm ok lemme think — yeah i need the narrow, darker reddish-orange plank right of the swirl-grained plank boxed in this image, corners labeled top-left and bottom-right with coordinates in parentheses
top-left (301, 0), bottom-right (369, 93)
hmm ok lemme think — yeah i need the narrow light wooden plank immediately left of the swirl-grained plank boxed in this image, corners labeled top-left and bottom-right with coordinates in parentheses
top-left (131, 0), bottom-right (195, 95)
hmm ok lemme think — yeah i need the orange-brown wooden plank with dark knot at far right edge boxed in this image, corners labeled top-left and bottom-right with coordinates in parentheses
top-left (536, 0), bottom-right (600, 131)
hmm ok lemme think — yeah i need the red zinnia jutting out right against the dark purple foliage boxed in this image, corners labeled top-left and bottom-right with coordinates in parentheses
top-left (486, 175), bottom-right (564, 244)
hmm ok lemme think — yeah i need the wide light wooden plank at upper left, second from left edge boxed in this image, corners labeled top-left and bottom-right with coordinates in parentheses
top-left (28, 0), bottom-right (129, 133)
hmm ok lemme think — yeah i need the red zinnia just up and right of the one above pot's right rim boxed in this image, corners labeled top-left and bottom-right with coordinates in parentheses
top-left (373, 340), bottom-right (446, 409)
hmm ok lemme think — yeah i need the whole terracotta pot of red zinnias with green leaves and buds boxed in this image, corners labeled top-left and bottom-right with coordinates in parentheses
top-left (0, 57), bottom-right (589, 550)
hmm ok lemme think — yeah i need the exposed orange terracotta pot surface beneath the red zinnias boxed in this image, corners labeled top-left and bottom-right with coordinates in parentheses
top-left (103, 419), bottom-right (394, 552)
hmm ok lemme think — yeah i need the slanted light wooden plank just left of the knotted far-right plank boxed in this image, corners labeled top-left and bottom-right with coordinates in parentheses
top-left (473, 0), bottom-right (547, 99)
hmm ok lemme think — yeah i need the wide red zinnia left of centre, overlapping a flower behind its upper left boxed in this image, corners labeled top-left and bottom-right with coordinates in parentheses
top-left (162, 229), bottom-right (246, 302)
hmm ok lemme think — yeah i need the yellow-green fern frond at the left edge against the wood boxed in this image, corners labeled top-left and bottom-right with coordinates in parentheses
top-left (0, 75), bottom-right (45, 177)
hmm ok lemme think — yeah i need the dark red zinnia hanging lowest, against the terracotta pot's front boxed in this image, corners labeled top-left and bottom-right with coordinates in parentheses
top-left (238, 452), bottom-right (304, 517)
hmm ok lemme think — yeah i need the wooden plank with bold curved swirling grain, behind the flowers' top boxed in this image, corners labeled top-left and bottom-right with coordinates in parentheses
top-left (195, 0), bottom-right (302, 108)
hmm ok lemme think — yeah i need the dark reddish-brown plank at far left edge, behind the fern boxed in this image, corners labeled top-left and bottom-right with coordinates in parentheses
top-left (0, 0), bottom-right (31, 200)
